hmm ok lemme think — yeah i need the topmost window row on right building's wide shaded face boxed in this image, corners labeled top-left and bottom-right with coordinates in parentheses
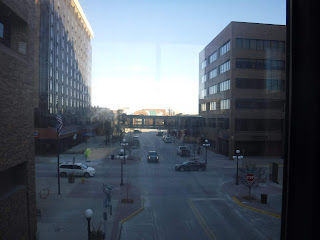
top-left (236, 38), bottom-right (285, 52)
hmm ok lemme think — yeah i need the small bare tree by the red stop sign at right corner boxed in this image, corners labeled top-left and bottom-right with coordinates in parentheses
top-left (238, 160), bottom-right (267, 196)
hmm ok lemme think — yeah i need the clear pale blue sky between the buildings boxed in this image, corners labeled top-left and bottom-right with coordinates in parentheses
top-left (79, 0), bottom-right (286, 114)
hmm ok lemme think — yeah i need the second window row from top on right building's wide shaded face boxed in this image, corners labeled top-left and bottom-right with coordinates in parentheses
top-left (236, 58), bottom-right (285, 70)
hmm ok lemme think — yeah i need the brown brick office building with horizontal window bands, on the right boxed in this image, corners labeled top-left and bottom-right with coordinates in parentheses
top-left (199, 22), bottom-right (286, 158)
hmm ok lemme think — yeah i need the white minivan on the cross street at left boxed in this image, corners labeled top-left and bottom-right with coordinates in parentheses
top-left (59, 162), bottom-right (96, 177)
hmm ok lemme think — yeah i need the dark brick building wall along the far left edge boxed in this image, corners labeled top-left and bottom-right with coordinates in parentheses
top-left (0, 0), bottom-right (39, 239)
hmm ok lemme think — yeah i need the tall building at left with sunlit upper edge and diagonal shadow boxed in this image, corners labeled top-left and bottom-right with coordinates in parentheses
top-left (35, 0), bottom-right (93, 154)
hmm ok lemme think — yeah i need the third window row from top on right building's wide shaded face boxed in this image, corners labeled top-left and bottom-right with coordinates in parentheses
top-left (236, 78), bottom-right (285, 92)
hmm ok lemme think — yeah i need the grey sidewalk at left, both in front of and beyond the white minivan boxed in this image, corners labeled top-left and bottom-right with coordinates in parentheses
top-left (36, 136), bottom-right (141, 240)
